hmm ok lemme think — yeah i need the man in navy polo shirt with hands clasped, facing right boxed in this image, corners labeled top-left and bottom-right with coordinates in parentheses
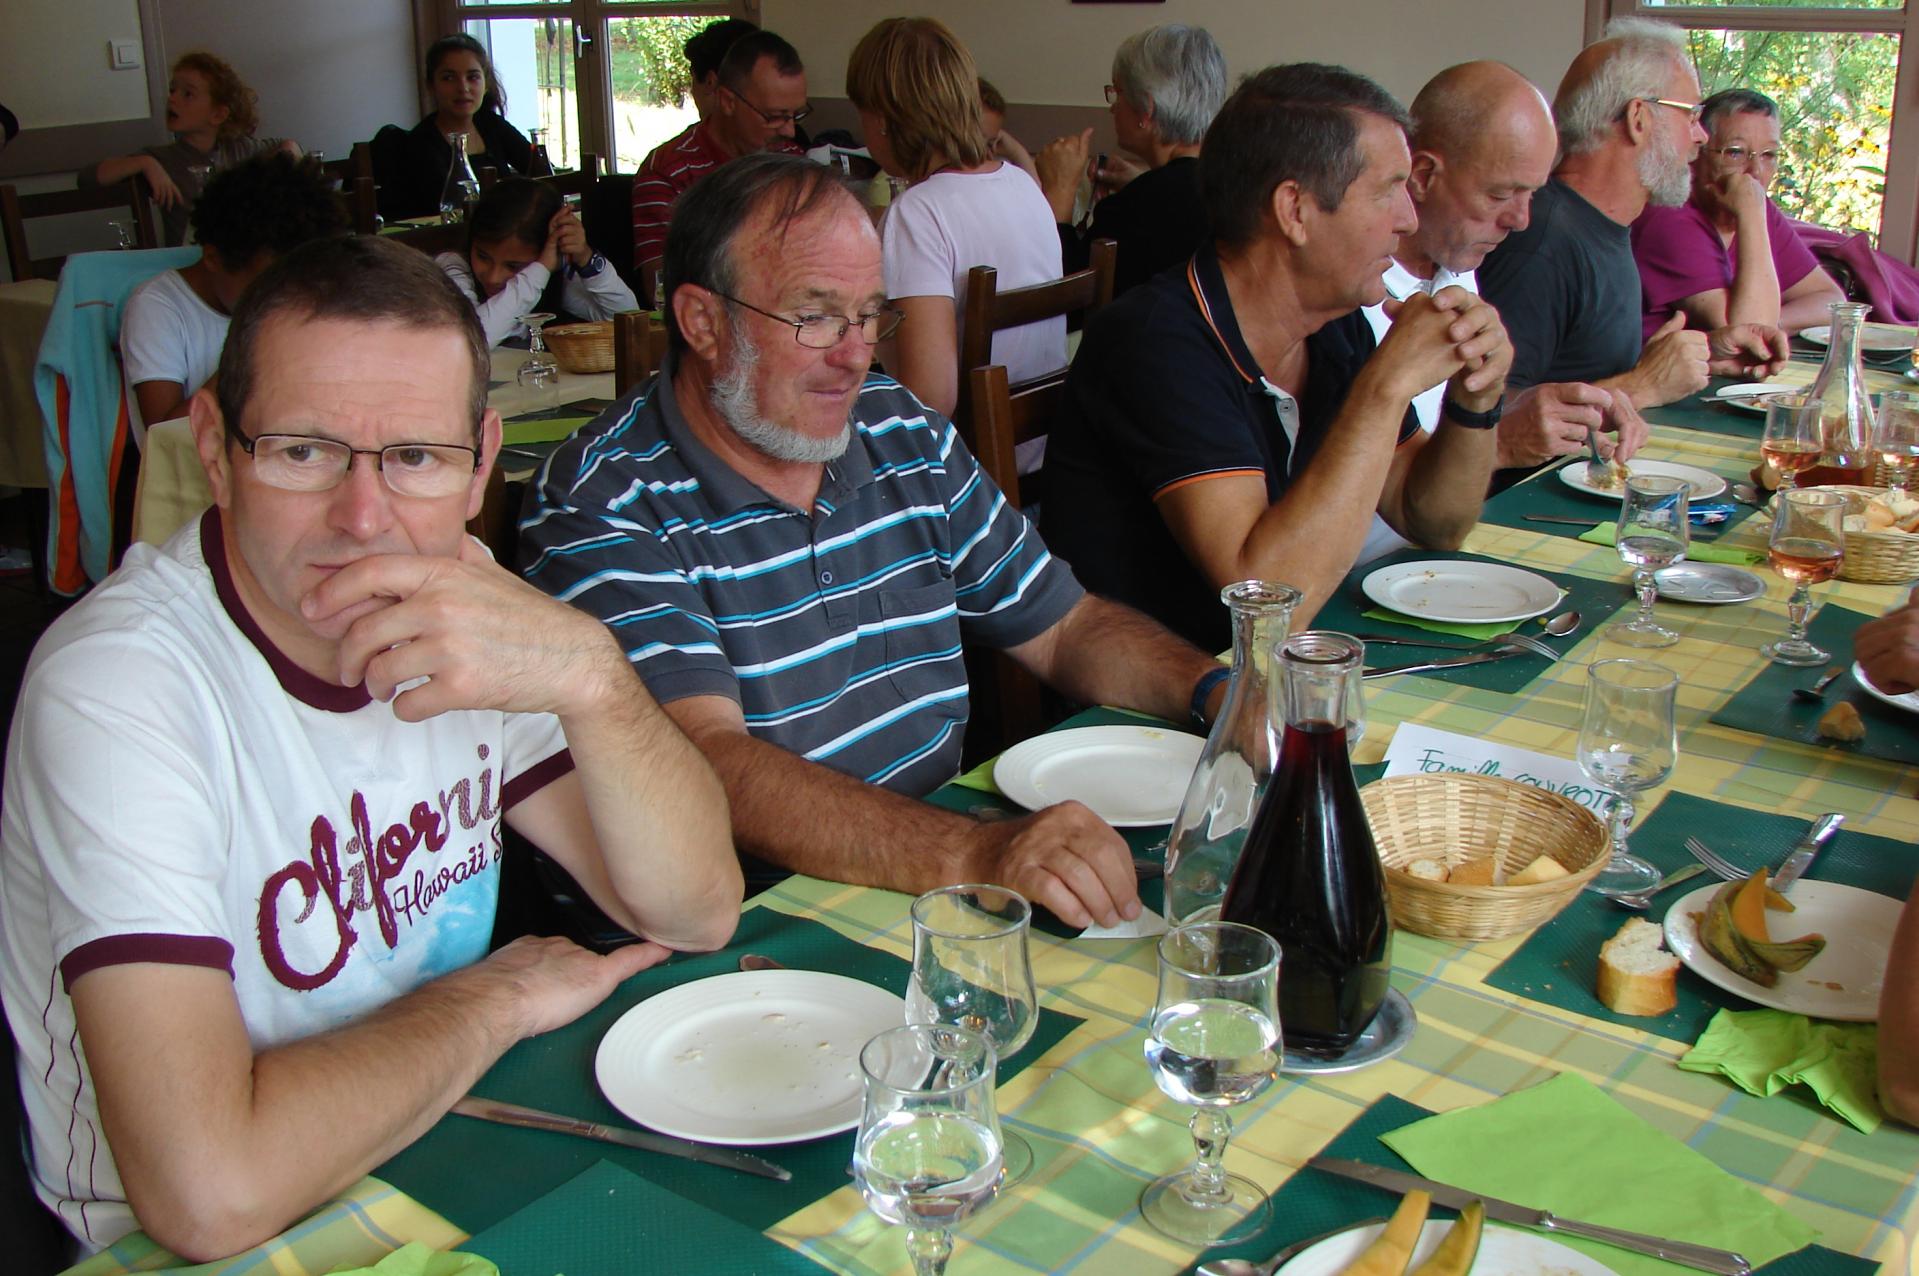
top-left (1044, 63), bottom-right (1512, 649)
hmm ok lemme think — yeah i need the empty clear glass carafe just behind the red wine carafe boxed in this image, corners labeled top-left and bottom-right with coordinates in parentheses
top-left (1167, 579), bottom-right (1299, 927)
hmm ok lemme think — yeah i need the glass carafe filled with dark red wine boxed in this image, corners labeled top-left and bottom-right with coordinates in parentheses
top-left (1219, 629), bottom-right (1393, 1057)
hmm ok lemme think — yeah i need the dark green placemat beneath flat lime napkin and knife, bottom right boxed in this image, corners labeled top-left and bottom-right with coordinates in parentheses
top-left (1186, 1094), bottom-right (1879, 1276)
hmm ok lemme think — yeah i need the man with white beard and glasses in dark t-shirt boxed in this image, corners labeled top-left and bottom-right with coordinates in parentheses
top-left (1480, 19), bottom-right (1789, 464)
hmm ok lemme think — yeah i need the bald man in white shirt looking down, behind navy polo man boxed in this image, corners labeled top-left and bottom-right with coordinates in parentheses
top-left (1359, 61), bottom-right (1565, 562)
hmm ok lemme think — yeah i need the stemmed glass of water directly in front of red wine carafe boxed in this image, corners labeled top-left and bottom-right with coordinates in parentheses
top-left (1140, 921), bottom-right (1280, 1245)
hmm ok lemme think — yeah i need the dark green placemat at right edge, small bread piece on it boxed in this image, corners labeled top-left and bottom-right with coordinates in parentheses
top-left (1712, 595), bottom-right (1919, 766)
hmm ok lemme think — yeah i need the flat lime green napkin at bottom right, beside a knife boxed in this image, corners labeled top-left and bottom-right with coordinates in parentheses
top-left (1382, 1073), bottom-right (1819, 1276)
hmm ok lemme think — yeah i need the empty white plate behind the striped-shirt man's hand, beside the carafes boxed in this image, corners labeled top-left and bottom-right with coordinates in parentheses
top-left (992, 727), bottom-right (1205, 829)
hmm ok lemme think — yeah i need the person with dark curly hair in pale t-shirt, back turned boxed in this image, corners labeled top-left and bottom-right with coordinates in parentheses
top-left (119, 152), bottom-right (347, 430)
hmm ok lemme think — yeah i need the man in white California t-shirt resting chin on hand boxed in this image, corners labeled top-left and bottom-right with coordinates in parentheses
top-left (0, 236), bottom-right (741, 1261)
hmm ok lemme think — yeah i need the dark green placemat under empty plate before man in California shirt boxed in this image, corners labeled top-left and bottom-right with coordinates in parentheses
top-left (374, 896), bottom-right (1080, 1232)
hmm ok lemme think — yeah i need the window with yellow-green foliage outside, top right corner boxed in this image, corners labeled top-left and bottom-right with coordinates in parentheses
top-left (1587, 0), bottom-right (1919, 261)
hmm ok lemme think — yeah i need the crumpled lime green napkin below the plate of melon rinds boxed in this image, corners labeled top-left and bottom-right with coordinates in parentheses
top-left (1679, 1009), bottom-right (1884, 1134)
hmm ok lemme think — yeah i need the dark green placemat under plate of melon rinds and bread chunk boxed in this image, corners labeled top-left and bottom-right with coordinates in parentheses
top-left (1485, 792), bottom-right (1919, 1042)
